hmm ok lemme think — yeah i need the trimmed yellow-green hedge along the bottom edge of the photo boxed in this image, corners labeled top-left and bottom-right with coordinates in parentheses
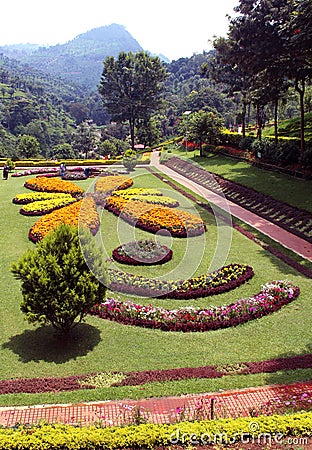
top-left (0, 412), bottom-right (312, 450)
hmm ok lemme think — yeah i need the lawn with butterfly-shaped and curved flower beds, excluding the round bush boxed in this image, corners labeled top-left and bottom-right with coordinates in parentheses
top-left (0, 160), bottom-right (311, 420)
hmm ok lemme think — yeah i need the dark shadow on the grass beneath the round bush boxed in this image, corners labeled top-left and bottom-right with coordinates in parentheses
top-left (1, 323), bottom-right (101, 364)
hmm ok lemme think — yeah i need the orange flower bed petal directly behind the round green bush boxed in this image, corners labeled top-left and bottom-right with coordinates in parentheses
top-left (28, 197), bottom-right (100, 242)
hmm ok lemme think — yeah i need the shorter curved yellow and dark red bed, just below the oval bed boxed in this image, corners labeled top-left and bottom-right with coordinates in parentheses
top-left (108, 264), bottom-right (254, 300)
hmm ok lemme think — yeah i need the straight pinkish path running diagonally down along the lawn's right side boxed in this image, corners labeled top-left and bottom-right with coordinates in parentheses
top-left (151, 151), bottom-right (312, 261)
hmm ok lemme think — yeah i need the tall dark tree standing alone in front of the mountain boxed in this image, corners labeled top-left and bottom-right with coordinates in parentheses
top-left (99, 52), bottom-right (167, 148)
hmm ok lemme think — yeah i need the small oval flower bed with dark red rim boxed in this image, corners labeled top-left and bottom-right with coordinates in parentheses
top-left (113, 239), bottom-right (172, 266)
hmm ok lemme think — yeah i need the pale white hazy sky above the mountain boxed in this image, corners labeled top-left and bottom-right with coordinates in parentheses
top-left (0, 0), bottom-right (239, 59)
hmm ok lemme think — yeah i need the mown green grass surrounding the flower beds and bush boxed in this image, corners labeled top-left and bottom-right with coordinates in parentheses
top-left (0, 169), bottom-right (312, 405)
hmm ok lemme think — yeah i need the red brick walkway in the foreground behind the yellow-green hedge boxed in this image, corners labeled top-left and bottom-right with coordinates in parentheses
top-left (0, 381), bottom-right (312, 426)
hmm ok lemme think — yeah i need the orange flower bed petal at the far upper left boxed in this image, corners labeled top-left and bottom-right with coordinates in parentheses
top-left (24, 177), bottom-right (84, 197)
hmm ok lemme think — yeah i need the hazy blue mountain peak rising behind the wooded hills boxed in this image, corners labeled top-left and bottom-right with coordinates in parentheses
top-left (0, 24), bottom-right (142, 88)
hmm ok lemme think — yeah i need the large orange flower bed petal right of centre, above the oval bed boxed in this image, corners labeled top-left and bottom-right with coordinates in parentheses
top-left (105, 196), bottom-right (206, 237)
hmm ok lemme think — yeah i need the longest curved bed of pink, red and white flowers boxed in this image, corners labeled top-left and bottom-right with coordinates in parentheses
top-left (91, 281), bottom-right (300, 332)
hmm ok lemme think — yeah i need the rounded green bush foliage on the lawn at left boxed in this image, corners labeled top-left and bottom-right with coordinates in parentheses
top-left (11, 225), bottom-right (106, 333)
